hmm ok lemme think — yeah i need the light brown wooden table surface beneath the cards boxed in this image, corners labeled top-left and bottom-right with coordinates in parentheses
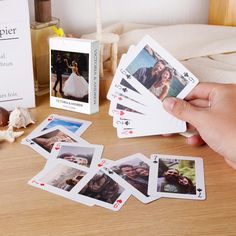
top-left (0, 93), bottom-right (236, 236)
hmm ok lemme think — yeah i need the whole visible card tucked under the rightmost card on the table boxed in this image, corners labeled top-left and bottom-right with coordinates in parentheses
top-left (104, 153), bottom-right (159, 203)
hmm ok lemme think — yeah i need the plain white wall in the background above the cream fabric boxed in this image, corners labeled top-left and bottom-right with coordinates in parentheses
top-left (28, 0), bottom-right (209, 34)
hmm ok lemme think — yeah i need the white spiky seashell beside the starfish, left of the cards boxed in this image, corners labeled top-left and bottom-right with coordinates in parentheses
top-left (8, 107), bottom-right (35, 129)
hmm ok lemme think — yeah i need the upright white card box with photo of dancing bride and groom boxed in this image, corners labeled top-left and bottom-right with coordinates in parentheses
top-left (49, 37), bottom-right (99, 114)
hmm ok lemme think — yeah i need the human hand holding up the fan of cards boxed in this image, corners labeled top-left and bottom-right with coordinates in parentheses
top-left (163, 83), bottom-right (236, 169)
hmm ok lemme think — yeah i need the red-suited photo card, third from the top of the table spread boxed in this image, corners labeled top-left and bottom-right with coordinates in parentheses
top-left (50, 143), bottom-right (103, 170)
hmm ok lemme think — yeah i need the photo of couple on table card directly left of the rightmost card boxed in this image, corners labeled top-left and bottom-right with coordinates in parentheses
top-left (111, 158), bottom-right (149, 196)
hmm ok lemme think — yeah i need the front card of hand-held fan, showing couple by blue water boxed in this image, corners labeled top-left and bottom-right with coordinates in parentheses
top-left (120, 35), bottom-right (199, 101)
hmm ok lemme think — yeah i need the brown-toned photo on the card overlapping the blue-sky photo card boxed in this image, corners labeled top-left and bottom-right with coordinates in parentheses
top-left (32, 129), bottom-right (76, 153)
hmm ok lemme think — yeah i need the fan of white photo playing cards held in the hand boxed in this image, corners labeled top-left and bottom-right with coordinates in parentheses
top-left (107, 36), bottom-right (198, 138)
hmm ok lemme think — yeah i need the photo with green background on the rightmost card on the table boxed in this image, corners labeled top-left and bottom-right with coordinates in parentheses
top-left (157, 158), bottom-right (196, 195)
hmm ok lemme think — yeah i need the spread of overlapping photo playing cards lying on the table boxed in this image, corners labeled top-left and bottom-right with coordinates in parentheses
top-left (22, 115), bottom-right (205, 211)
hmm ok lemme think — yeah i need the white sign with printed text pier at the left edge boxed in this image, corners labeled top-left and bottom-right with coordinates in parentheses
top-left (0, 0), bottom-right (35, 110)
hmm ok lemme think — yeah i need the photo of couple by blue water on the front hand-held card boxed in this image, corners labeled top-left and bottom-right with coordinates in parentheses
top-left (126, 44), bottom-right (188, 101)
